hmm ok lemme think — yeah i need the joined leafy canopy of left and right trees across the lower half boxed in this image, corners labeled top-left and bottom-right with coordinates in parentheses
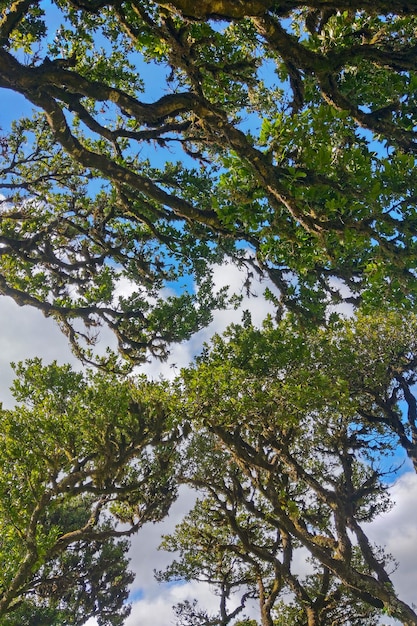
top-left (0, 313), bottom-right (417, 626)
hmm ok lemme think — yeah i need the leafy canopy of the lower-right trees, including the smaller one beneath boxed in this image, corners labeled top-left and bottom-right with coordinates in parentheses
top-left (172, 314), bottom-right (417, 626)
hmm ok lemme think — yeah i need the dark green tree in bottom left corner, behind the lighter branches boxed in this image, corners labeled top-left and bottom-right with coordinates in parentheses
top-left (1, 497), bottom-right (134, 626)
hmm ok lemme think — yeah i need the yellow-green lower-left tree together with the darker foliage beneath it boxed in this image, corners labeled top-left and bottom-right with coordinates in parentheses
top-left (0, 360), bottom-right (181, 626)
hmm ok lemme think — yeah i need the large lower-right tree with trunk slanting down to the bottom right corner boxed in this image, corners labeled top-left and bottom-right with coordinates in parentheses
top-left (176, 320), bottom-right (417, 625)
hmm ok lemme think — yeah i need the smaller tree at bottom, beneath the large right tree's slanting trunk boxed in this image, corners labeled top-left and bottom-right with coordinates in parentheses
top-left (157, 488), bottom-right (380, 626)
